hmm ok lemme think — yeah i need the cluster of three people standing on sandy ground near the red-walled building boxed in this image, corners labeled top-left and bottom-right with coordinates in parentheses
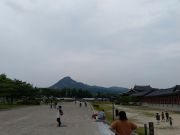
top-left (156, 111), bottom-right (172, 126)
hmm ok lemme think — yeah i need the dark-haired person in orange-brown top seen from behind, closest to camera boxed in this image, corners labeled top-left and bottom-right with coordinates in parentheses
top-left (110, 111), bottom-right (137, 135)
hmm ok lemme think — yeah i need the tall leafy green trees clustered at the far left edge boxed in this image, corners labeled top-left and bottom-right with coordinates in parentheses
top-left (0, 74), bottom-right (38, 104)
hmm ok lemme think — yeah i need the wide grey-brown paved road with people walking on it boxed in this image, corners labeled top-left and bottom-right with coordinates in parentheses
top-left (0, 102), bottom-right (112, 135)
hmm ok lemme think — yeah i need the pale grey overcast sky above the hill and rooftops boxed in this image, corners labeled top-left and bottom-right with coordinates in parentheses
top-left (0, 0), bottom-right (180, 88)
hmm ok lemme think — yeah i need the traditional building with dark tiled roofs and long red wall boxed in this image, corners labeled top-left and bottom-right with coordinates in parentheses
top-left (126, 85), bottom-right (180, 111)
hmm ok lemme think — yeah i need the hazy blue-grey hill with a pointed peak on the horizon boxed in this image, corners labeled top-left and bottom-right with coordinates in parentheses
top-left (49, 77), bottom-right (128, 93)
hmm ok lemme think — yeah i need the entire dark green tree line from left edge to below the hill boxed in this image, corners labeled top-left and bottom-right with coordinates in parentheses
top-left (0, 74), bottom-right (108, 104)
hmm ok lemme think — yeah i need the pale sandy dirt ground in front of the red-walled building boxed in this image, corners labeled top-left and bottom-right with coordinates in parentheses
top-left (116, 106), bottom-right (180, 135)
